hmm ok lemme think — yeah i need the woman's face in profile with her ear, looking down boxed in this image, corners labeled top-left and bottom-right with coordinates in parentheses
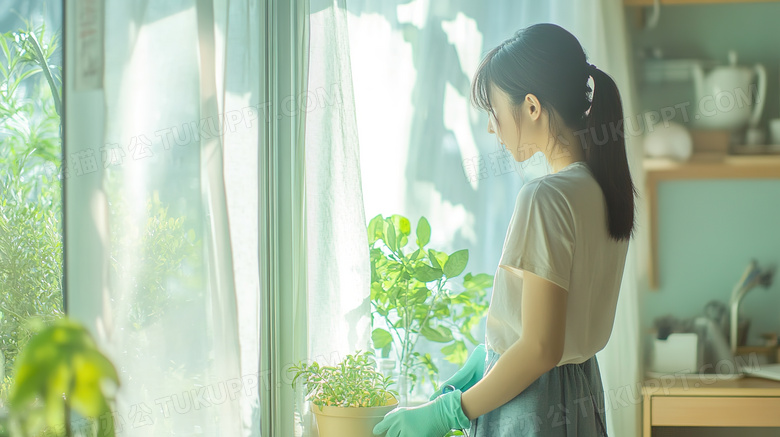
top-left (488, 84), bottom-right (544, 162)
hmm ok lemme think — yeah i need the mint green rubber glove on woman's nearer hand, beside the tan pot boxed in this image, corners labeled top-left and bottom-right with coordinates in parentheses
top-left (373, 390), bottom-right (471, 437)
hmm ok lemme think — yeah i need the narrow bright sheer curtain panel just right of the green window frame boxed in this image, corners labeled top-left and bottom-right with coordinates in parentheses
top-left (296, 0), bottom-right (371, 435)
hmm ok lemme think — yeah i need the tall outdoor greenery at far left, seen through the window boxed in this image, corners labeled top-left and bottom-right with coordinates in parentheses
top-left (0, 23), bottom-right (62, 382)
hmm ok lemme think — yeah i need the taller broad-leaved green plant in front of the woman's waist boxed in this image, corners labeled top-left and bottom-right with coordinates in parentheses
top-left (368, 214), bottom-right (493, 393)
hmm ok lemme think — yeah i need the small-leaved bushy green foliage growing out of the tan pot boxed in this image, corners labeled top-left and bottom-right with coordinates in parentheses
top-left (289, 351), bottom-right (398, 407)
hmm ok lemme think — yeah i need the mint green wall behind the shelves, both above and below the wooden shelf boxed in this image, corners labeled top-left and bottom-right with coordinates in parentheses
top-left (627, 2), bottom-right (780, 354)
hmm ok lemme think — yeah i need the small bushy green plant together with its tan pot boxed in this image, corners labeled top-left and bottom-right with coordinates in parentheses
top-left (289, 351), bottom-right (398, 437)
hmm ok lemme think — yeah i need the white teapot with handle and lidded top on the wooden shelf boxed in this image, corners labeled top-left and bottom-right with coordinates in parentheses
top-left (692, 50), bottom-right (766, 130)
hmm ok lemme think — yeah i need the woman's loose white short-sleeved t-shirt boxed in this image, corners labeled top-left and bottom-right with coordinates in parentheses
top-left (485, 161), bottom-right (628, 366)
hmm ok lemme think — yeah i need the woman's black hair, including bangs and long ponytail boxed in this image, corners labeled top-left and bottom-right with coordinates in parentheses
top-left (471, 23), bottom-right (637, 241)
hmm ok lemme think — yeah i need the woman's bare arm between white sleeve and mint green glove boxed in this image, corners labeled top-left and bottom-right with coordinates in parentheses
top-left (461, 265), bottom-right (568, 420)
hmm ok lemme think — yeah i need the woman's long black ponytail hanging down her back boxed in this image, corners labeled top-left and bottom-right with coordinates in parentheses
top-left (583, 64), bottom-right (637, 241)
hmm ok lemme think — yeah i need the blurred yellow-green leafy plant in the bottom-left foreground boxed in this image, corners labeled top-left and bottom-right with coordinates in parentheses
top-left (9, 317), bottom-right (119, 437)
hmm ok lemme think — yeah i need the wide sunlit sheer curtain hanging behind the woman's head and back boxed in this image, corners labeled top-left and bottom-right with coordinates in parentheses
top-left (347, 0), bottom-right (645, 436)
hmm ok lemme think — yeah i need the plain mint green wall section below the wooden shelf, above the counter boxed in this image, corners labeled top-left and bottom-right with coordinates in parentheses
top-left (642, 180), bottom-right (780, 342)
